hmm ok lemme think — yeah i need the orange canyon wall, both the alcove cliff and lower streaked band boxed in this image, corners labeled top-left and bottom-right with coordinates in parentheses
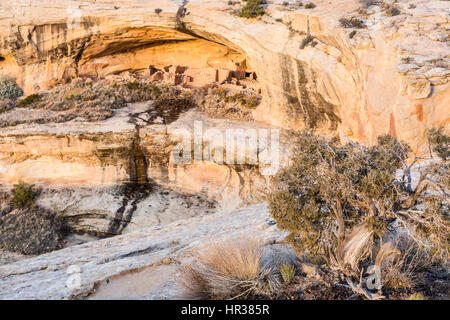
top-left (0, 0), bottom-right (450, 203)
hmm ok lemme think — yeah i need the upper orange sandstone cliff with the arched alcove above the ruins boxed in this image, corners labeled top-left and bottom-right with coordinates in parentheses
top-left (0, 0), bottom-right (450, 145)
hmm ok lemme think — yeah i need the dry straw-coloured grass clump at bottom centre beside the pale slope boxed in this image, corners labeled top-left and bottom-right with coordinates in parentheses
top-left (181, 239), bottom-right (280, 299)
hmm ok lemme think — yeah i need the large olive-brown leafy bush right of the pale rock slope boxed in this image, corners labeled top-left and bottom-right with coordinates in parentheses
top-left (270, 132), bottom-right (408, 260)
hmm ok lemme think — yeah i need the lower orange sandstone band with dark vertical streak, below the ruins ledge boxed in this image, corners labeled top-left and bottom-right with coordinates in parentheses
top-left (0, 102), bottom-right (289, 210)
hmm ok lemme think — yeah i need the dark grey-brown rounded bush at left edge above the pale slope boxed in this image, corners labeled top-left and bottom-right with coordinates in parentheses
top-left (0, 205), bottom-right (63, 254)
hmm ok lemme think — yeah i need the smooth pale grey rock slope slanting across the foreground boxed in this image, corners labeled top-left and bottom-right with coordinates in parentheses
top-left (0, 204), bottom-right (285, 299)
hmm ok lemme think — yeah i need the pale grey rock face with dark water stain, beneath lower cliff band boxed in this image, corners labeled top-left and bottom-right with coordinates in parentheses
top-left (36, 185), bottom-right (217, 236)
